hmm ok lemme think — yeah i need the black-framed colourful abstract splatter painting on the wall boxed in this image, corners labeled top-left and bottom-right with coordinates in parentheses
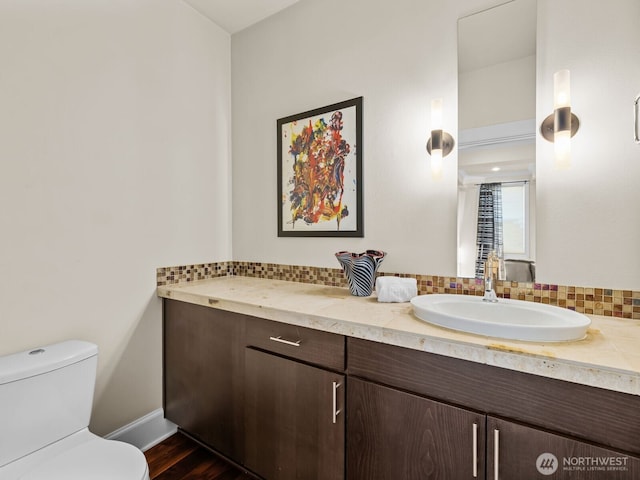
top-left (277, 97), bottom-right (364, 237)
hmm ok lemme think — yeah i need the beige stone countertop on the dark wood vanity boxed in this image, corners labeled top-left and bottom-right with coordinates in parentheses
top-left (157, 277), bottom-right (640, 395)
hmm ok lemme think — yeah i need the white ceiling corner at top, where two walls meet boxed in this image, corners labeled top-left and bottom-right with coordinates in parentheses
top-left (184, 0), bottom-right (298, 34)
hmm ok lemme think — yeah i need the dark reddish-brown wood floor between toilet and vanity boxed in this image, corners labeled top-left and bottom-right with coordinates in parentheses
top-left (145, 432), bottom-right (254, 480)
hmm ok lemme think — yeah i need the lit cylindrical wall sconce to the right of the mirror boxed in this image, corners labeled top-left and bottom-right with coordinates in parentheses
top-left (540, 70), bottom-right (580, 169)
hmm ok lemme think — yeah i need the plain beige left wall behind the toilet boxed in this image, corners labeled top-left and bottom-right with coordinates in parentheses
top-left (0, 0), bottom-right (231, 434)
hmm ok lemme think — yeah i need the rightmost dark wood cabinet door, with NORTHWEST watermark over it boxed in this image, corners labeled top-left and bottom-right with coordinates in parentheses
top-left (487, 417), bottom-right (640, 480)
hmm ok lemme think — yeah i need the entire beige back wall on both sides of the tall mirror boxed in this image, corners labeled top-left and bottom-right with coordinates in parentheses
top-left (232, 0), bottom-right (640, 290)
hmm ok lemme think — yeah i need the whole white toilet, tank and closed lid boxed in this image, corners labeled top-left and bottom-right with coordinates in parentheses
top-left (0, 340), bottom-right (149, 480)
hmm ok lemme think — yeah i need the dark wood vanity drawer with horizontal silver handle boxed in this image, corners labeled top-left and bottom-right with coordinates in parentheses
top-left (246, 318), bottom-right (345, 372)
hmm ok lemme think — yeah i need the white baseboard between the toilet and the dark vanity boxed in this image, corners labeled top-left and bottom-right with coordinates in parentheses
top-left (104, 408), bottom-right (178, 452)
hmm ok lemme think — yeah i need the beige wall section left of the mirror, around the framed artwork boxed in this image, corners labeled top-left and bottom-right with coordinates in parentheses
top-left (231, 0), bottom-right (478, 275)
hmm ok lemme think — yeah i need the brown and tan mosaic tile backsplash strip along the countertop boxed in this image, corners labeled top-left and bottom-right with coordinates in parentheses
top-left (156, 261), bottom-right (640, 320)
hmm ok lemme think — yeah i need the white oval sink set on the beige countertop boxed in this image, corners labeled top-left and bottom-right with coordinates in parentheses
top-left (411, 294), bottom-right (591, 342)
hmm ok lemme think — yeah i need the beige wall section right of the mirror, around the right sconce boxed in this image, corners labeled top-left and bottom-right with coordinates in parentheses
top-left (536, 0), bottom-right (640, 290)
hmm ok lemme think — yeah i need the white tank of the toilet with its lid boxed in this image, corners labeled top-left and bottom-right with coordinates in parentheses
top-left (0, 340), bottom-right (98, 467)
